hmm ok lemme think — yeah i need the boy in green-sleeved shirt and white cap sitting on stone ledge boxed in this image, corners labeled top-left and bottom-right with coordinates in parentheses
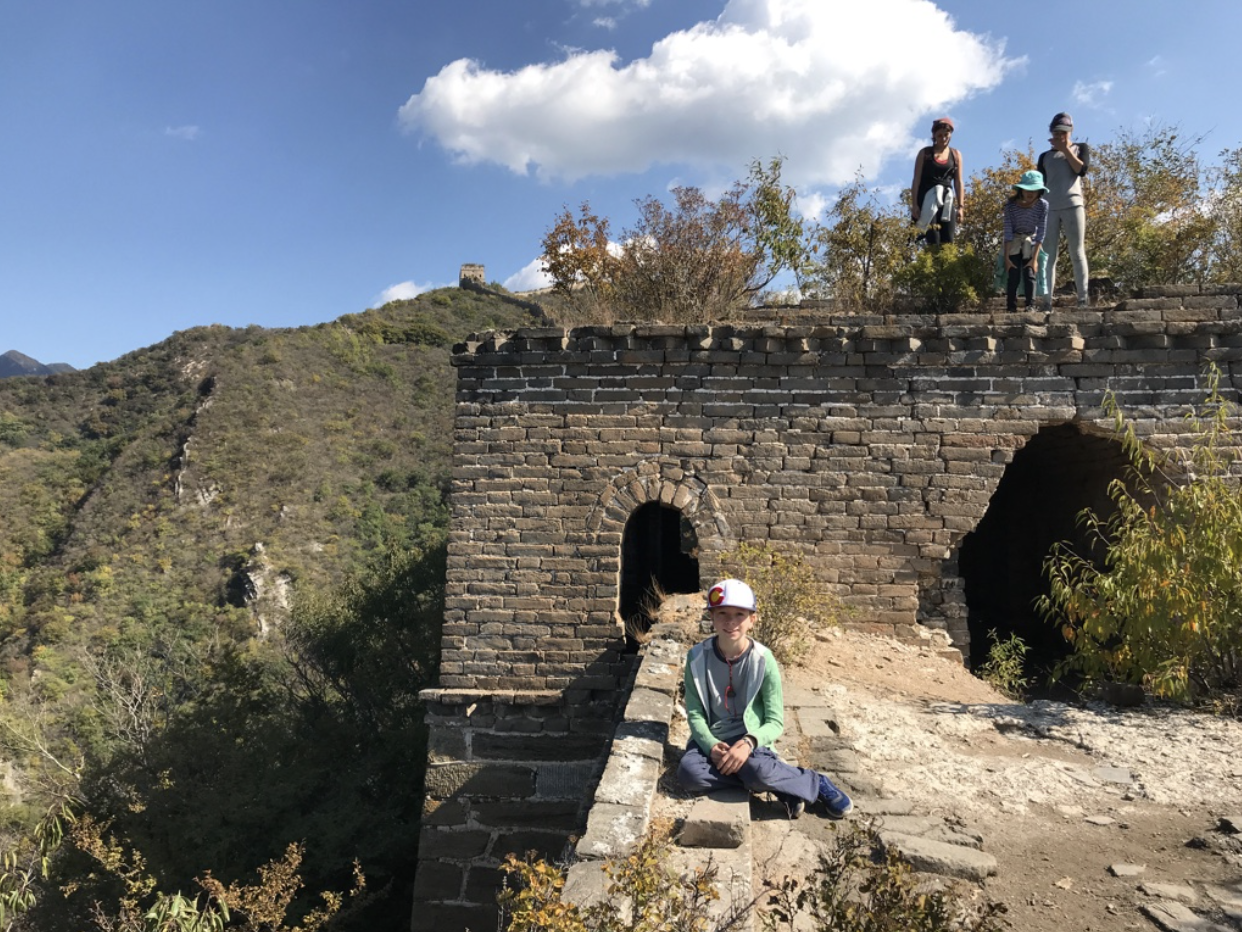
top-left (677, 579), bottom-right (853, 819)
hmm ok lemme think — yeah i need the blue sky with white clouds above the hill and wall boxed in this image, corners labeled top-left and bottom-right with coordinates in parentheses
top-left (0, 0), bottom-right (1242, 368)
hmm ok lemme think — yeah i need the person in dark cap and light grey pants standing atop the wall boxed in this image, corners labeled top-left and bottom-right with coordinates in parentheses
top-left (1038, 113), bottom-right (1090, 307)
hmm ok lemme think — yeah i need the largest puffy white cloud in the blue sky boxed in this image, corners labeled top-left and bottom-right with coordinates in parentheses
top-left (399, 0), bottom-right (1023, 184)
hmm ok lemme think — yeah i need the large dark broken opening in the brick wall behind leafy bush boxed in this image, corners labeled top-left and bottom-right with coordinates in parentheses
top-left (959, 424), bottom-right (1129, 693)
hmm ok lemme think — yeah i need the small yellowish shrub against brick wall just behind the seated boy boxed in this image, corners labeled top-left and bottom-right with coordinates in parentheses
top-left (724, 543), bottom-right (842, 664)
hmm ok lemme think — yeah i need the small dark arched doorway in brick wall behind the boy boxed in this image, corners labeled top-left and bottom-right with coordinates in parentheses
top-left (617, 502), bottom-right (700, 647)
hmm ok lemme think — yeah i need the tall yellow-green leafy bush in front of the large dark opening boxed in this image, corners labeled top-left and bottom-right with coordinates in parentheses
top-left (1038, 370), bottom-right (1242, 700)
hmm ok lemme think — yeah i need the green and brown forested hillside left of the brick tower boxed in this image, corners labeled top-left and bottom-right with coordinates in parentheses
top-left (0, 288), bottom-right (530, 930)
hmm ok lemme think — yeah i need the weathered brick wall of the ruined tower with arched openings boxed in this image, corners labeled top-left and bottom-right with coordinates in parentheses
top-left (415, 286), bottom-right (1242, 928)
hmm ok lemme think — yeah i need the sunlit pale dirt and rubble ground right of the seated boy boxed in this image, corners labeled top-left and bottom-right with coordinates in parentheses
top-left (789, 631), bottom-right (1242, 932)
